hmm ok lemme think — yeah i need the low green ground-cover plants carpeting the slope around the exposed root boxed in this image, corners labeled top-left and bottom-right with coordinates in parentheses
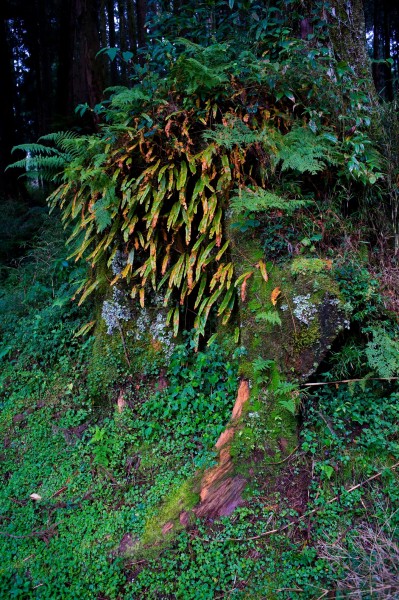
top-left (0, 227), bottom-right (399, 600)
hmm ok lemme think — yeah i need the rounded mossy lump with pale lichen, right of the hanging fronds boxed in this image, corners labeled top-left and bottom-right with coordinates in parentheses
top-left (232, 234), bottom-right (348, 381)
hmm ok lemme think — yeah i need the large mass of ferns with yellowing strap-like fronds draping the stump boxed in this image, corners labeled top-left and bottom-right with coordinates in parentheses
top-left (9, 22), bottom-right (380, 342)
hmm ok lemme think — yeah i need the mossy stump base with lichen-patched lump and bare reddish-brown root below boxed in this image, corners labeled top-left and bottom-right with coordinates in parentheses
top-left (180, 225), bottom-right (346, 518)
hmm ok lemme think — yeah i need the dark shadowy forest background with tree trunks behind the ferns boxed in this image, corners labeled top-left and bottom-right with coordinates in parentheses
top-left (0, 0), bottom-right (399, 186)
